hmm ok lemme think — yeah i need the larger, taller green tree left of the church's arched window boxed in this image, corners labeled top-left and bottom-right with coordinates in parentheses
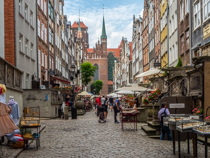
top-left (81, 62), bottom-right (97, 91)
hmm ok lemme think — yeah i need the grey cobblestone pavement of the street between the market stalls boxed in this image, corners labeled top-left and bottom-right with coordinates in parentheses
top-left (14, 112), bottom-right (210, 158)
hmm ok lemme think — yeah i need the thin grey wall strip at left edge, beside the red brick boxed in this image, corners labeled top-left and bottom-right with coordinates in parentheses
top-left (0, 1), bottom-right (5, 59)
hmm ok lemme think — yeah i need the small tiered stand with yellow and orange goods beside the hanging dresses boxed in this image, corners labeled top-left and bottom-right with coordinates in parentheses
top-left (21, 106), bottom-right (41, 149)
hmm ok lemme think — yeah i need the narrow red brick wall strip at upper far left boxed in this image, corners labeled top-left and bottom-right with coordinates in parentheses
top-left (4, 0), bottom-right (16, 66)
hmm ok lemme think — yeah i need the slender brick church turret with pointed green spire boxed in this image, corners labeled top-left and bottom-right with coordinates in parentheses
top-left (101, 16), bottom-right (107, 58)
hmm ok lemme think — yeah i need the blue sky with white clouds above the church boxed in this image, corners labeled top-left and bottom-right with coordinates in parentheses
top-left (64, 0), bottom-right (144, 48)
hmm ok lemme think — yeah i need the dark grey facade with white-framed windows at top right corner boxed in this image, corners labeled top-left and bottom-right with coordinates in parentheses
top-left (190, 0), bottom-right (210, 57)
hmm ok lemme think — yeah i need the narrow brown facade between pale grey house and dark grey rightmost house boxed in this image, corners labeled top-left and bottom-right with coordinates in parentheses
top-left (178, 0), bottom-right (191, 65)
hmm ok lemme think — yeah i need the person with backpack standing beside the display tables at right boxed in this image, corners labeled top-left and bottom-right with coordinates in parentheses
top-left (158, 102), bottom-right (172, 140)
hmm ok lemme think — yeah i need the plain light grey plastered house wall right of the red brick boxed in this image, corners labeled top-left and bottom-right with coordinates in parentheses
top-left (15, 0), bottom-right (37, 89)
